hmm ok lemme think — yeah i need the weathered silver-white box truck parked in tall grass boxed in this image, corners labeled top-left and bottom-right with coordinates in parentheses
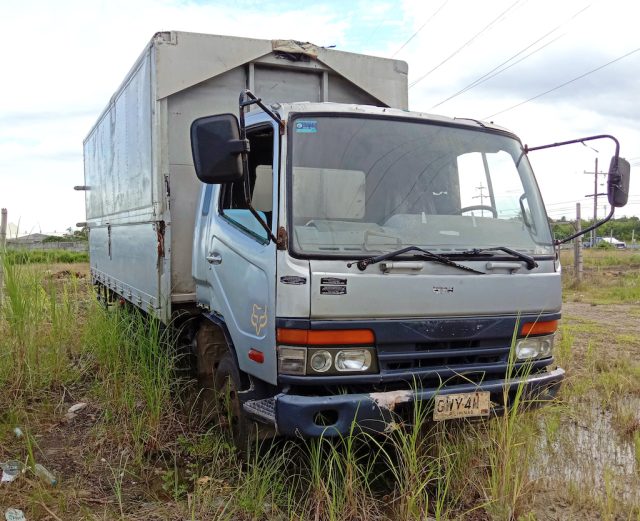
top-left (80, 32), bottom-right (629, 440)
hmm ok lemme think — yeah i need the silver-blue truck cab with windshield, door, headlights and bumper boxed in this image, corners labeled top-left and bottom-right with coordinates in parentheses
top-left (192, 103), bottom-right (564, 436)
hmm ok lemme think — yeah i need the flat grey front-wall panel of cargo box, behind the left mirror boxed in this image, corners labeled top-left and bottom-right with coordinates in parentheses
top-left (168, 67), bottom-right (246, 296)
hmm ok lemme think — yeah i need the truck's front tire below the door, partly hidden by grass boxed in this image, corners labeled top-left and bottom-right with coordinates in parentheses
top-left (214, 352), bottom-right (257, 454)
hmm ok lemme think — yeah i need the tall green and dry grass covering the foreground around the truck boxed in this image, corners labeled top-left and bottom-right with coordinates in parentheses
top-left (0, 258), bottom-right (640, 521)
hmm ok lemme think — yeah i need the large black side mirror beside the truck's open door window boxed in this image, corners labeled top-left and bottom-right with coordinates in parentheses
top-left (191, 114), bottom-right (249, 184)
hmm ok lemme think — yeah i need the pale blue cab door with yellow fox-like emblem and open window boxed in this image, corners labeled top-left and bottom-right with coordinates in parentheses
top-left (206, 120), bottom-right (279, 384)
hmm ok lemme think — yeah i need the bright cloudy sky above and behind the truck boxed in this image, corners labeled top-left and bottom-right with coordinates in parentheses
top-left (0, 0), bottom-right (640, 234)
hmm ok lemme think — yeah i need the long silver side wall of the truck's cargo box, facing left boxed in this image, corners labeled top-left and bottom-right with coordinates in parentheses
top-left (84, 48), bottom-right (169, 318)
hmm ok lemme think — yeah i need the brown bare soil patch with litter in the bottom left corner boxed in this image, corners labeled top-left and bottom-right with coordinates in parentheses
top-left (0, 390), bottom-right (182, 521)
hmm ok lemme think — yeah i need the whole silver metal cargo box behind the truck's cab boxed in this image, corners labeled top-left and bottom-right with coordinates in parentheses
top-left (84, 32), bottom-right (407, 322)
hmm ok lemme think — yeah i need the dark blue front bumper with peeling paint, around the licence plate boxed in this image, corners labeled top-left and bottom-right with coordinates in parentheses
top-left (275, 368), bottom-right (565, 437)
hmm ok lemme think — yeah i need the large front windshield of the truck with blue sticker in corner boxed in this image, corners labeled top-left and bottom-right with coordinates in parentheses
top-left (289, 115), bottom-right (553, 256)
